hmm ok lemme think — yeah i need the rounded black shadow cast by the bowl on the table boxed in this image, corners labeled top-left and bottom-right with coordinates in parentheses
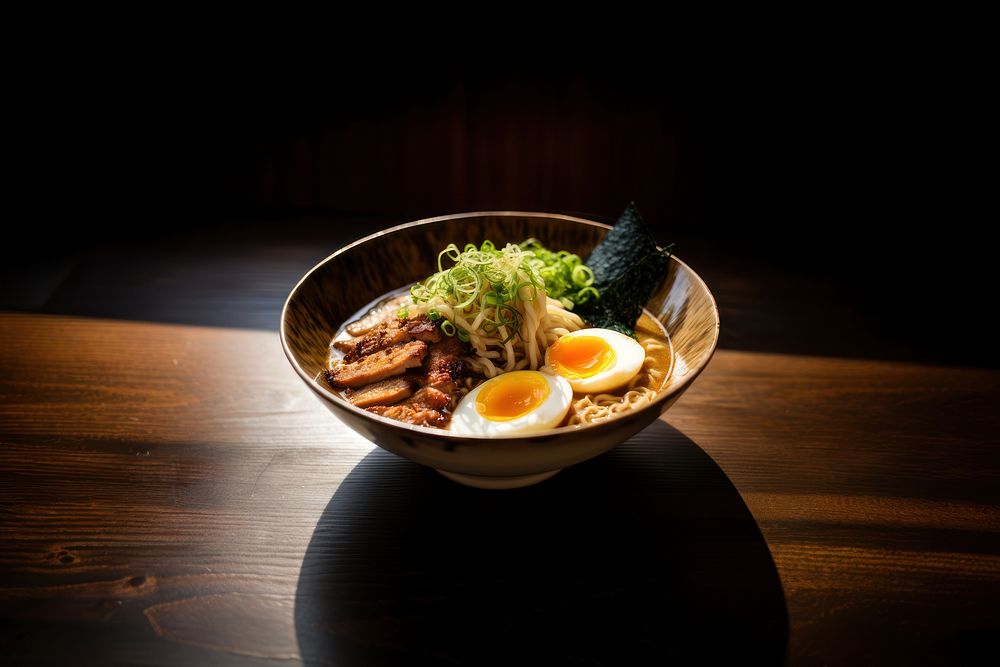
top-left (295, 422), bottom-right (788, 666)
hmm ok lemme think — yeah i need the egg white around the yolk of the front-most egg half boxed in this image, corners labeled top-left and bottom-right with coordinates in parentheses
top-left (449, 371), bottom-right (573, 436)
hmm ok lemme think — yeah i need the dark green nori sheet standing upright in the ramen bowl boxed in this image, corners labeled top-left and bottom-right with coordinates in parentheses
top-left (575, 202), bottom-right (673, 337)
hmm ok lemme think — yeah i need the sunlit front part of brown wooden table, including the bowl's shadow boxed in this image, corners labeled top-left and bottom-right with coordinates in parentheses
top-left (0, 314), bottom-right (1000, 665)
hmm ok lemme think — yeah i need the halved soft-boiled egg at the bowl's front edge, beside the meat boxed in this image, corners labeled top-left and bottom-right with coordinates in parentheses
top-left (450, 371), bottom-right (573, 436)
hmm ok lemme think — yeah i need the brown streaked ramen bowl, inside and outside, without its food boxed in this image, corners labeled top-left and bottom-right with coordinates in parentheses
top-left (280, 211), bottom-right (719, 489)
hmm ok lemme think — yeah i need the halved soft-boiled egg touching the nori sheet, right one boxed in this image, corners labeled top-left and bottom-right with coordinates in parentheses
top-left (545, 329), bottom-right (646, 394)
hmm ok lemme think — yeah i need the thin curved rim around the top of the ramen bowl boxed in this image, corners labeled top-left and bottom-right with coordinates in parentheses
top-left (278, 211), bottom-right (721, 441)
